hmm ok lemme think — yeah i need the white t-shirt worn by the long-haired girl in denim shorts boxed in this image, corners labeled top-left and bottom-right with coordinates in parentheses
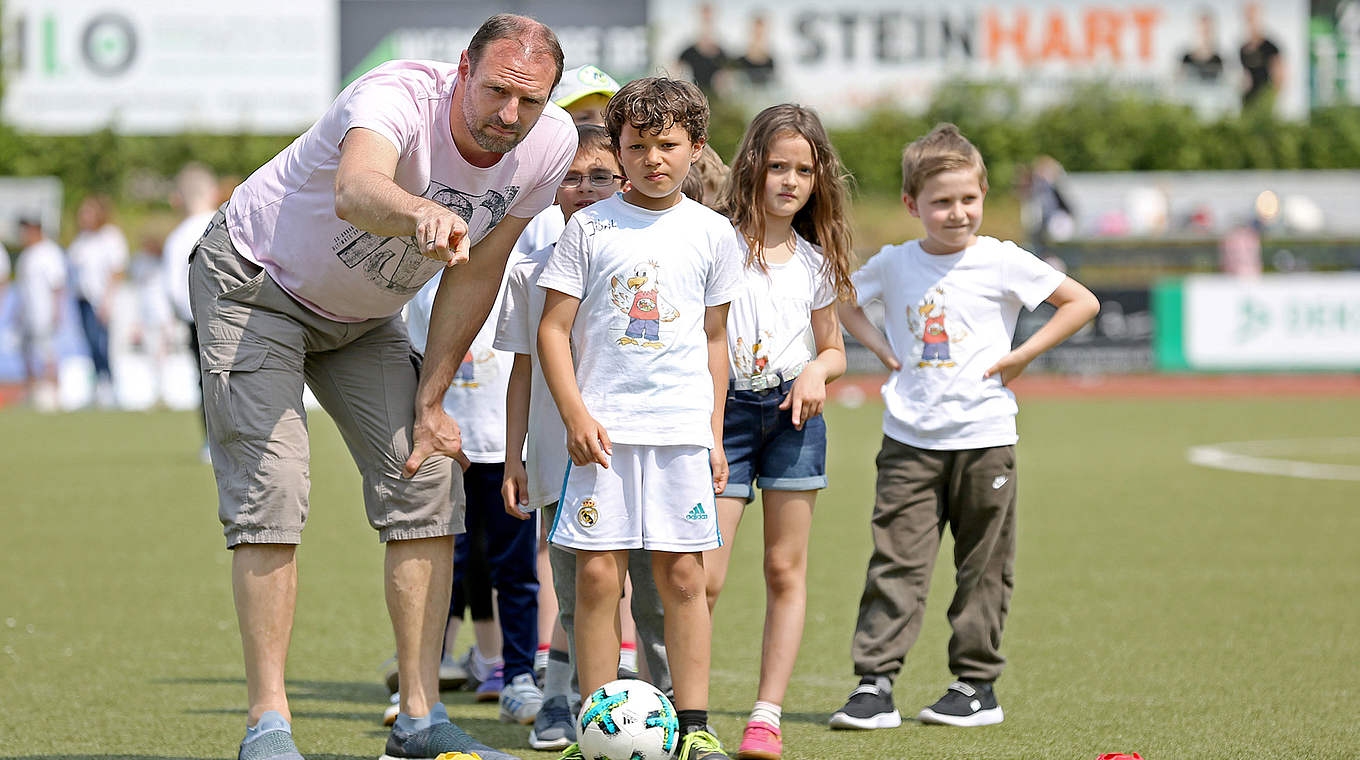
top-left (728, 235), bottom-right (836, 381)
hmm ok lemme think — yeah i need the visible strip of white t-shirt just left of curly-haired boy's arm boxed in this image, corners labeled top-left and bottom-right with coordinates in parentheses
top-left (494, 245), bottom-right (568, 510)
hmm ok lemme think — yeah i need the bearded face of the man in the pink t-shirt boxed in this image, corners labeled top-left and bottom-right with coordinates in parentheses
top-left (458, 39), bottom-right (558, 154)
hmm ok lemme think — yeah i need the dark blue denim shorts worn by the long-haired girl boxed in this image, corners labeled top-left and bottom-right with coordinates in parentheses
top-left (719, 379), bottom-right (827, 502)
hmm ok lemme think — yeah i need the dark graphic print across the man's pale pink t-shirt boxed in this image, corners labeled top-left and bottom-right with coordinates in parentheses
top-left (332, 181), bottom-right (520, 295)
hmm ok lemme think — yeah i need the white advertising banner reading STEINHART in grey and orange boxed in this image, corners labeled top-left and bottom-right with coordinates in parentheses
top-left (651, 0), bottom-right (1310, 120)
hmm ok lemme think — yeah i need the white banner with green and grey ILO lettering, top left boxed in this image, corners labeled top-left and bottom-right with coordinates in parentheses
top-left (0, 0), bottom-right (337, 135)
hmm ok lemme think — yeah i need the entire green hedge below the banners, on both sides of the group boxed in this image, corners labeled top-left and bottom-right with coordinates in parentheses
top-left (0, 84), bottom-right (1360, 207)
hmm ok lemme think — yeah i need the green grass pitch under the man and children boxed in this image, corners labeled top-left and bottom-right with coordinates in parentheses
top-left (0, 398), bottom-right (1360, 760)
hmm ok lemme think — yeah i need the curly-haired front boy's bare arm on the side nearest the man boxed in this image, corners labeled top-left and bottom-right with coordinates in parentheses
top-left (539, 288), bottom-right (613, 468)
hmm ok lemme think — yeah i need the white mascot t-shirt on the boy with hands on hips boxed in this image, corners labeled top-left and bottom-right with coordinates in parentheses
top-left (851, 237), bottom-right (1065, 450)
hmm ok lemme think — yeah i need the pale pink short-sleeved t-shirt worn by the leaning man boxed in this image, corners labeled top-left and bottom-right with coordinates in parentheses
top-left (227, 61), bottom-right (577, 322)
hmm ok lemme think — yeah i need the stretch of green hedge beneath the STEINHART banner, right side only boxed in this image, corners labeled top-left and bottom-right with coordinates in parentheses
top-left (711, 84), bottom-right (1360, 196)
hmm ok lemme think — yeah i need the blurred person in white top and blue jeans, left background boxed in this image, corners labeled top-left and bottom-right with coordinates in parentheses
top-left (67, 194), bottom-right (128, 407)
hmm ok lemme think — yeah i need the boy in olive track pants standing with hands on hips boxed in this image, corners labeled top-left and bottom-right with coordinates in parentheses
top-left (831, 124), bottom-right (1100, 729)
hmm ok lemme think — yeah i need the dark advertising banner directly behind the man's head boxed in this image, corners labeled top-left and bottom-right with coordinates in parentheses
top-left (340, 0), bottom-right (649, 84)
